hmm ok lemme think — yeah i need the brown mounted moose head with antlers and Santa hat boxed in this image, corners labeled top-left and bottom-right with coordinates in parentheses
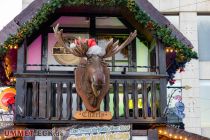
top-left (53, 24), bottom-right (137, 112)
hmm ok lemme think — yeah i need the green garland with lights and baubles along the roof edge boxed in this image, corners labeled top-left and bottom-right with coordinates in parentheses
top-left (0, 0), bottom-right (198, 85)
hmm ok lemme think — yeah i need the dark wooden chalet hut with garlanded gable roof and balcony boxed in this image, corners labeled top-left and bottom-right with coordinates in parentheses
top-left (0, 0), bottom-right (200, 140)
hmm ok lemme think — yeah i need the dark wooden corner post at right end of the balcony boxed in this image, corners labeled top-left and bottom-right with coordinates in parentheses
top-left (157, 40), bottom-right (167, 116)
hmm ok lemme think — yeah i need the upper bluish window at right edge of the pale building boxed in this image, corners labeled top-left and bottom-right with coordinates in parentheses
top-left (198, 16), bottom-right (210, 61)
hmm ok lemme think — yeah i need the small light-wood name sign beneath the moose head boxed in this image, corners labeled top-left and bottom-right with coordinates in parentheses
top-left (74, 111), bottom-right (112, 120)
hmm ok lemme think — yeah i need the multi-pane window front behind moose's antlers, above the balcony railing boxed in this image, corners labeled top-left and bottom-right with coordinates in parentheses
top-left (28, 16), bottom-right (157, 73)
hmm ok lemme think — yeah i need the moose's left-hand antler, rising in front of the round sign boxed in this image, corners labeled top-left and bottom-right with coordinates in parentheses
top-left (53, 24), bottom-right (88, 57)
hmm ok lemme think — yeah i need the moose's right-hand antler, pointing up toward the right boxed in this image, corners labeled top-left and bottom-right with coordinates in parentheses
top-left (103, 30), bottom-right (137, 58)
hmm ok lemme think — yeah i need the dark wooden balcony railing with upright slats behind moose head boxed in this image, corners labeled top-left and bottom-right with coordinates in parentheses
top-left (15, 73), bottom-right (166, 124)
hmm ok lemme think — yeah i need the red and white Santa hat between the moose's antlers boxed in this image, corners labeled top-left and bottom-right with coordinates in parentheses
top-left (86, 38), bottom-right (104, 56)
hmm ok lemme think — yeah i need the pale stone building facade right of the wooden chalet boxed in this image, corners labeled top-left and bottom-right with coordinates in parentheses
top-left (146, 0), bottom-right (210, 137)
